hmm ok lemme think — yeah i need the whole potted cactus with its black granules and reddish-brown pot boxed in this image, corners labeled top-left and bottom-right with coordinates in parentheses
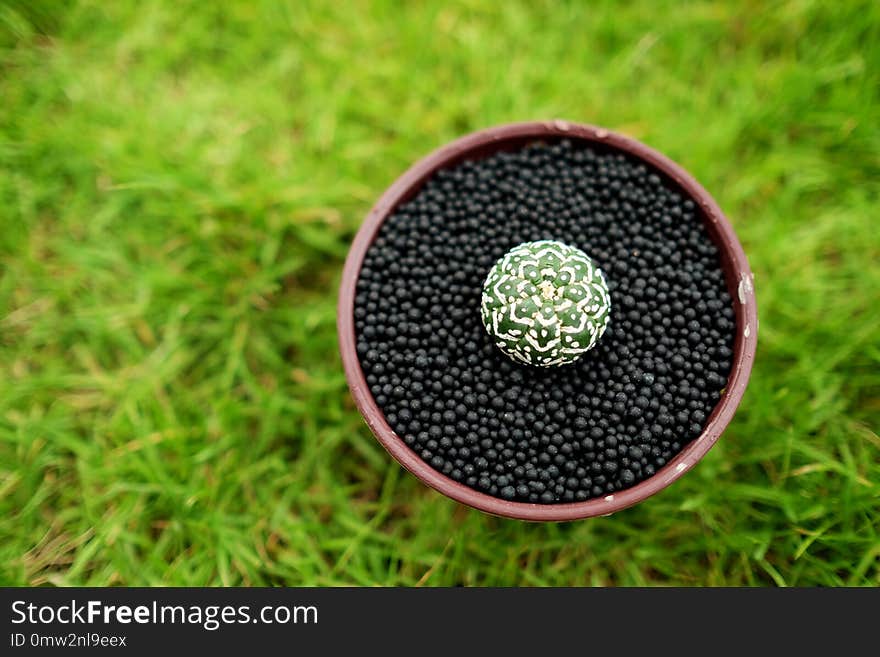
top-left (338, 120), bottom-right (757, 520)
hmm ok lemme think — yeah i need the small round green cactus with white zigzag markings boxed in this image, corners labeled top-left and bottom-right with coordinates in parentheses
top-left (480, 240), bottom-right (611, 367)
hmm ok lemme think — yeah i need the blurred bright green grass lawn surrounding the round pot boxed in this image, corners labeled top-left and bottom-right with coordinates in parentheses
top-left (0, 0), bottom-right (880, 586)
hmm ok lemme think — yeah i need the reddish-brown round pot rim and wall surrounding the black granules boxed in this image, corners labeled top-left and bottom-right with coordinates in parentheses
top-left (337, 120), bottom-right (758, 521)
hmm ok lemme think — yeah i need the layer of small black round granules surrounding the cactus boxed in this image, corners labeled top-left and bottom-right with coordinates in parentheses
top-left (354, 142), bottom-right (735, 504)
